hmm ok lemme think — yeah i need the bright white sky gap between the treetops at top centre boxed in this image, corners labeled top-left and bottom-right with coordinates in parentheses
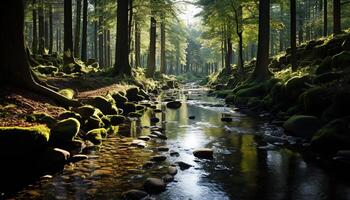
top-left (177, 0), bottom-right (201, 25)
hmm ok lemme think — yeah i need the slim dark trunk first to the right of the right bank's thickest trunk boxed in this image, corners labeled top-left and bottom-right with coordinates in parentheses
top-left (290, 0), bottom-right (297, 71)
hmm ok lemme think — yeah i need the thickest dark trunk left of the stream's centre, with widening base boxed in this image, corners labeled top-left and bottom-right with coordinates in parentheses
top-left (114, 0), bottom-right (131, 76)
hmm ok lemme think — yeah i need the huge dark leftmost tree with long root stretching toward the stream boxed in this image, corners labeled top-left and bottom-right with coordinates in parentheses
top-left (0, 0), bottom-right (79, 106)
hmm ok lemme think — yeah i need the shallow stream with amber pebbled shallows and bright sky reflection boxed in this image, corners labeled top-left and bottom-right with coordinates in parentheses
top-left (10, 85), bottom-right (350, 200)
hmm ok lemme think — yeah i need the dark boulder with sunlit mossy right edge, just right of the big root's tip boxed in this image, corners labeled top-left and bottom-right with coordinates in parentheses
top-left (88, 96), bottom-right (118, 115)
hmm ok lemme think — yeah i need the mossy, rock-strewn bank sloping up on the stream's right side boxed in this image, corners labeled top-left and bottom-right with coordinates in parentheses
top-left (207, 32), bottom-right (350, 164)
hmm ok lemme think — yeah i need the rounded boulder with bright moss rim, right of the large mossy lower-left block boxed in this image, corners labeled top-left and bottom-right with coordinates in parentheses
top-left (50, 118), bottom-right (80, 142)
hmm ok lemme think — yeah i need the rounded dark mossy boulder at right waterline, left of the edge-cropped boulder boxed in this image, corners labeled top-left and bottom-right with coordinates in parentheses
top-left (283, 115), bottom-right (321, 139)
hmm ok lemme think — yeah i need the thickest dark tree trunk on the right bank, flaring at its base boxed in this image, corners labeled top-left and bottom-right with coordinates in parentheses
top-left (252, 0), bottom-right (270, 81)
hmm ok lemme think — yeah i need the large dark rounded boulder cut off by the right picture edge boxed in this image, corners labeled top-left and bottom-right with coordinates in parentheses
top-left (311, 117), bottom-right (350, 154)
